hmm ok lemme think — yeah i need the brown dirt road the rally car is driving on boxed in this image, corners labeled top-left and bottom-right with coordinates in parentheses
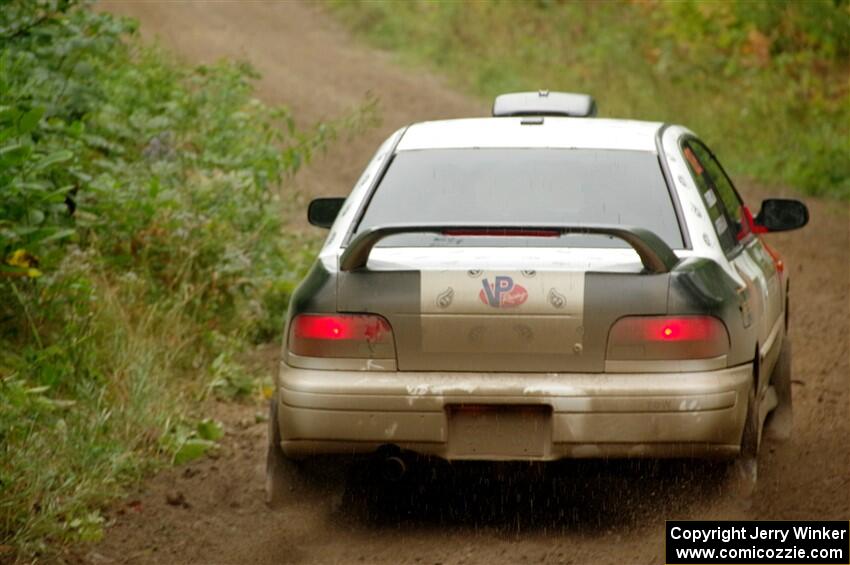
top-left (78, 2), bottom-right (850, 564)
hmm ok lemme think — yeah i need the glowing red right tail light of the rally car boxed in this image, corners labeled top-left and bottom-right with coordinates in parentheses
top-left (607, 316), bottom-right (729, 361)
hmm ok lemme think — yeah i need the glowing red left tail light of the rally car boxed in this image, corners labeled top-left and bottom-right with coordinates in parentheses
top-left (289, 314), bottom-right (395, 359)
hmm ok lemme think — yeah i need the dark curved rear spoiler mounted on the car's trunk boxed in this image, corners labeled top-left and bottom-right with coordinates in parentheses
top-left (339, 224), bottom-right (679, 273)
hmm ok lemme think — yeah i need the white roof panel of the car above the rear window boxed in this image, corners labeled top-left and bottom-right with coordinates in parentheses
top-left (396, 116), bottom-right (663, 153)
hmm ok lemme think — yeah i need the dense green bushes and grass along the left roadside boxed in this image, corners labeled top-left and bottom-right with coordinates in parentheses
top-left (0, 0), bottom-right (374, 560)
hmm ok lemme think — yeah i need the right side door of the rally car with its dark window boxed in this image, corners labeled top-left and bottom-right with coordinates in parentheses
top-left (682, 138), bottom-right (785, 386)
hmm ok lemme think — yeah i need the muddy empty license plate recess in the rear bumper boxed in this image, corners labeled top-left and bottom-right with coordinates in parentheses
top-left (446, 404), bottom-right (552, 459)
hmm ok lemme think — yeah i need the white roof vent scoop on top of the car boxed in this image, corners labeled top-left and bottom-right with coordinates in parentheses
top-left (493, 90), bottom-right (596, 118)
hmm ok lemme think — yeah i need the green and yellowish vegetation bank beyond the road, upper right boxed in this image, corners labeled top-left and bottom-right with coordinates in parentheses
top-left (333, 0), bottom-right (850, 199)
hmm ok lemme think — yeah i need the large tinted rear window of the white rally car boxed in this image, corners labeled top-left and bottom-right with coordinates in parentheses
top-left (355, 149), bottom-right (684, 249)
